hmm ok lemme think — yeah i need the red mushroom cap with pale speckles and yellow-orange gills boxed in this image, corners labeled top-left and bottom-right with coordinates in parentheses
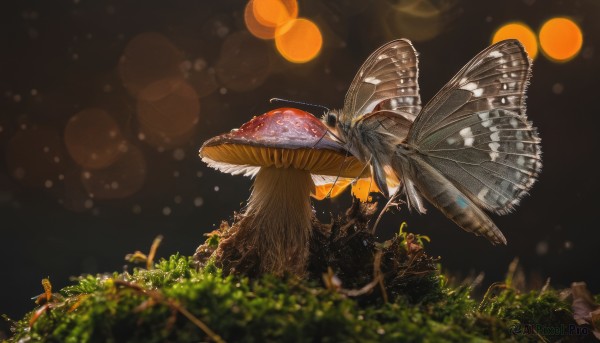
top-left (200, 108), bottom-right (368, 178)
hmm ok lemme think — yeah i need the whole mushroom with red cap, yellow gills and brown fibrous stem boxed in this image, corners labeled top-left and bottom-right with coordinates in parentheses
top-left (199, 108), bottom-right (365, 276)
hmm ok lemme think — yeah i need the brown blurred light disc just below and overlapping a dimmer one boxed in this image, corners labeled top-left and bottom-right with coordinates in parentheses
top-left (137, 83), bottom-right (200, 148)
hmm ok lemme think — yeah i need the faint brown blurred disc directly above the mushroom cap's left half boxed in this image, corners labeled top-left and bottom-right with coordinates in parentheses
top-left (215, 31), bottom-right (270, 92)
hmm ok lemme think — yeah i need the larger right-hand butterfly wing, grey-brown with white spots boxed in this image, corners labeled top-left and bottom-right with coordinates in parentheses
top-left (400, 40), bottom-right (541, 245)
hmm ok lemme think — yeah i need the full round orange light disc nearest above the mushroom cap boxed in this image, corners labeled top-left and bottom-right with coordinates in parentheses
top-left (275, 18), bottom-right (323, 63)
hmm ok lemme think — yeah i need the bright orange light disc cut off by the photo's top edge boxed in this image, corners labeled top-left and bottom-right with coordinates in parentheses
top-left (251, 0), bottom-right (298, 27)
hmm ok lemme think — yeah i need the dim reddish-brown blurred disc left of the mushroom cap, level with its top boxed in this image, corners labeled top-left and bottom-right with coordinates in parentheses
top-left (64, 108), bottom-right (127, 169)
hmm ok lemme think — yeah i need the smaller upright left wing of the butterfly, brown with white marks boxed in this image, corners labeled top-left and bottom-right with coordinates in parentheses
top-left (343, 39), bottom-right (421, 120)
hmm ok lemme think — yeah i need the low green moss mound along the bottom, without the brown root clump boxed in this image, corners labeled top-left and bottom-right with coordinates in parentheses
top-left (3, 251), bottom-right (593, 342)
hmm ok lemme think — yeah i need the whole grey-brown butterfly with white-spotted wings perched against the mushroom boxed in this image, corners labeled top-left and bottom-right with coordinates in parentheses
top-left (322, 39), bottom-right (542, 244)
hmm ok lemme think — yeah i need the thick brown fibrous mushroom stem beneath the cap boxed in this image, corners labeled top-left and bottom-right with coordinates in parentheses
top-left (224, 167), bottom-right (314, 276)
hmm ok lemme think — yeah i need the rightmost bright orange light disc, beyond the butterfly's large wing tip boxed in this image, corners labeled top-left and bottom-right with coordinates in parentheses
top-left (540, 18), bottom-right (583, 62)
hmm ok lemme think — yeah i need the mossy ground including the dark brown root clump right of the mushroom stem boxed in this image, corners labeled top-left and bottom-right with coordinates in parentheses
top-left (3, 205), bottom-right (599, 342)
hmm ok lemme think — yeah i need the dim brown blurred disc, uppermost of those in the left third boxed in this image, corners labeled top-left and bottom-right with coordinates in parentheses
top-left (119, 32), bottom-right (183, 96)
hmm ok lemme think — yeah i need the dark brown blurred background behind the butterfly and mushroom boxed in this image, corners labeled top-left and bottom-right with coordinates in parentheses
top-left (0, 0), bottom-right (600, 337)
